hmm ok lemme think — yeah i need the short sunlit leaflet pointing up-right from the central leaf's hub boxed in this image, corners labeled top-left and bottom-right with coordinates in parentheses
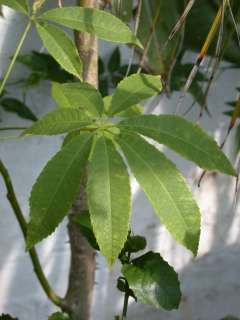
top-left (109, 73), bottom-right (162, 115)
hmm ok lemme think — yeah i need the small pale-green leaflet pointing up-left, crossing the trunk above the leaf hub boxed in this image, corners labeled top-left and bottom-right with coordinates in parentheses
top-left (52, 82), bottom-right (103, 117)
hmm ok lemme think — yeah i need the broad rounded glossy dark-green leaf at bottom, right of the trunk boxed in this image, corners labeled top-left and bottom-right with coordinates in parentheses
top-left (122, 252), bottom-right (181, 310)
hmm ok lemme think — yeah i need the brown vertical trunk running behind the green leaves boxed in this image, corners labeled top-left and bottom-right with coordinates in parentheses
top-left (65, 0), bottom-right (98, 320)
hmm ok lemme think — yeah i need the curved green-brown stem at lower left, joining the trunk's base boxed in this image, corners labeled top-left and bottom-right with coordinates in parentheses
top-left (0, 160), bottom-right (63, 308)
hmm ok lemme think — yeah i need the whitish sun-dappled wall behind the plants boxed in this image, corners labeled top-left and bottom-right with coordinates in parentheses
top-left (0, 6), bottom-right (240, 320)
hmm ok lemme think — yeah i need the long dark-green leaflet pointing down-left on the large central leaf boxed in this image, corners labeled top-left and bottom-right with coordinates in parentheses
top-left (27, 133), bottom-right (92, 249)
